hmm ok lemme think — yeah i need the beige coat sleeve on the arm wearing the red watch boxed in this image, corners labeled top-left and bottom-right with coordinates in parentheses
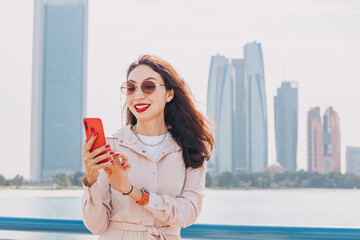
top-left (144, 165), bottom-right (206, 228)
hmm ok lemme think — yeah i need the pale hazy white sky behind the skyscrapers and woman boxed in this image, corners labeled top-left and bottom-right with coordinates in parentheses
top-left (0, 0), bottom-right (360, 179)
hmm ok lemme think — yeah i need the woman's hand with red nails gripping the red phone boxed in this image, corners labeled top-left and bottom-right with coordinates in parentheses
top-left (82, 133), bottom-right (114, 187)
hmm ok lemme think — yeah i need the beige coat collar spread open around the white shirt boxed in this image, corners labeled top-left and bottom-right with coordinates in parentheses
top-left (112, 124), bottom-right (181, 161)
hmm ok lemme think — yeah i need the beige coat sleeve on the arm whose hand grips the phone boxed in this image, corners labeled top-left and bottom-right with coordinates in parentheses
top-left (82, 138), bottom-right (113, 234)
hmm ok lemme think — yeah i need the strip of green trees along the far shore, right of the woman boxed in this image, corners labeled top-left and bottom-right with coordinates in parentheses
top-left (206, 170), bottom-right (360, 189)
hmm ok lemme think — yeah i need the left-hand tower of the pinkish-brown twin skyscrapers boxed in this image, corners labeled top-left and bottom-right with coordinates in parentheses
top-left (307, 107), bottom-right (323, 173)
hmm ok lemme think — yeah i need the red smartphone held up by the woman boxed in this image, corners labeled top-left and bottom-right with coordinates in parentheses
top-left (83, 118), bottom-right (110, 164)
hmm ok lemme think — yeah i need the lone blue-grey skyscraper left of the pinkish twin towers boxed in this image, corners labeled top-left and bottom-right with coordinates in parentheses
top-left (274, 82), bottom-right (298, 171)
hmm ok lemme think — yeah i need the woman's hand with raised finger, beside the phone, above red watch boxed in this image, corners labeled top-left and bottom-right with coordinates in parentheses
top-left (107, 153), bottom-right (131, 193)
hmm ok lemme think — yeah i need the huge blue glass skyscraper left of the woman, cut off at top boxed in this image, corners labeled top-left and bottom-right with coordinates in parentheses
top-left (30, 0), bottom-right (88, 182)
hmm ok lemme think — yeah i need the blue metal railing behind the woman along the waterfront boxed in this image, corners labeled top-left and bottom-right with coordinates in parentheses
top-left (0, 217), bottom-right (360, 239)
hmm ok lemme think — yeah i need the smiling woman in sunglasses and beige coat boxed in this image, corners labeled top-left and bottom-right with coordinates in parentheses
top-left (82, 55), bottom-right (214, 240)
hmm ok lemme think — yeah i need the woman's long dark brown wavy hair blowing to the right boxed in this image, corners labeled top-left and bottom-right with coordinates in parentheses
top-left (126, 55), bottom-right (214, 168)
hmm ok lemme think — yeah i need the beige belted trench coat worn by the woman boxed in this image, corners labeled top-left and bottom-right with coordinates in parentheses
top-left (82, 125), bottom-right (206, 240)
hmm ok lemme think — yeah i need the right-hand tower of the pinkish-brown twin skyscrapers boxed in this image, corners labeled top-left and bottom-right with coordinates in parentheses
top-left (323, 107), bottom-right (340, 173)
